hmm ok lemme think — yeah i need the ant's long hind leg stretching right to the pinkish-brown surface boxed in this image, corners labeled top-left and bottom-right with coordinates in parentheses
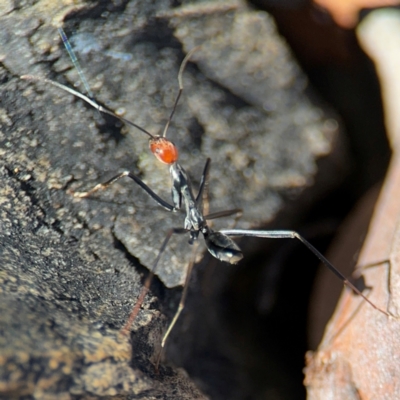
top-left (220, 229), bottom-right (391, 317)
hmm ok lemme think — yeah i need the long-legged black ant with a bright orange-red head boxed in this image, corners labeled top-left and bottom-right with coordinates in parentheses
top-left (21, 28), bottom-right (390, 370)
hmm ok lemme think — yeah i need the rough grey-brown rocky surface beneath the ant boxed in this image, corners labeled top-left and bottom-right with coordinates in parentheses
top-left (0, 1), bottom-right (344, 399)
